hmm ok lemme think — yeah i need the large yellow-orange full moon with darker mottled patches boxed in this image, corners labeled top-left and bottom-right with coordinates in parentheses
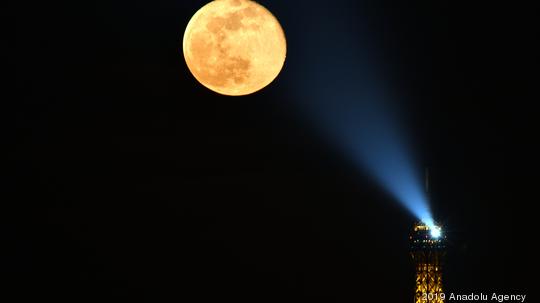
top-left (183, 0), bottom-right (287, 96)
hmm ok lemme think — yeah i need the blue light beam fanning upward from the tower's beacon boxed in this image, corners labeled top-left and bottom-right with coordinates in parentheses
top-left (288, 4), bottom-right (435, 227)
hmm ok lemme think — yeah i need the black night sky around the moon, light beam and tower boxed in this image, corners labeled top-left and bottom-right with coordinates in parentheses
top-left (11, 0), bottom-right (538, 302)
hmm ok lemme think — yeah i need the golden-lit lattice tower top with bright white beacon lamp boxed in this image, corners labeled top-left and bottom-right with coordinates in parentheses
top-left (409, 222), bottom-right (446, 303)
